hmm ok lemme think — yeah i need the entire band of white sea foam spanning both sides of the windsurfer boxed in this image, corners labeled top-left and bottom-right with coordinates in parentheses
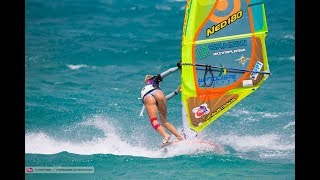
top-left (25, 115), bottom-right (295, 158)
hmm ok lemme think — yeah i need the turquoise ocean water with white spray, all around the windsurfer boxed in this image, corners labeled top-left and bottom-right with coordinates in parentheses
top-left (25, 0), bottom-right (295, 180)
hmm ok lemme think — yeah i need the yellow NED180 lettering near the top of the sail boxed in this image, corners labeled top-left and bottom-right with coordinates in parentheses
top-left (206, 10), bottom-right (243, 37)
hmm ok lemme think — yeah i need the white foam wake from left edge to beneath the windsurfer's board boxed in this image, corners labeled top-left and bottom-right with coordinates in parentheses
top-left (25, 116), bottom-right (220, 158)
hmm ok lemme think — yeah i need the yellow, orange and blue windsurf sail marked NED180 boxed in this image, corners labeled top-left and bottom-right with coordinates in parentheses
top-left (181, 0), bottom-right (270, 132)
